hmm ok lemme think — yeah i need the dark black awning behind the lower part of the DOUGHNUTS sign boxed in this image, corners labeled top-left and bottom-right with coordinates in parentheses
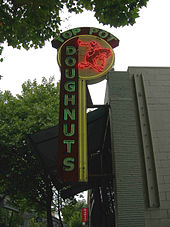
top-left (29, 106), bottom-right (111, 195)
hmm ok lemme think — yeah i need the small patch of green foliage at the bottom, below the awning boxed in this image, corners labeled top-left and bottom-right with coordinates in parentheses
top-left (61, 199), bottom-right (87, 227)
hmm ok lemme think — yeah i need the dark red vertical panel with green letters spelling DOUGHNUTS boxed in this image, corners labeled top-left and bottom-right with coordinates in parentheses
top-left (58, 38), bottom-right (79, 182)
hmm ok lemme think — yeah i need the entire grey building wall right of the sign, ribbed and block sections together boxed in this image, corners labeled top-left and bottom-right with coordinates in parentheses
top-left (106, 67), bottom-right (170, 227)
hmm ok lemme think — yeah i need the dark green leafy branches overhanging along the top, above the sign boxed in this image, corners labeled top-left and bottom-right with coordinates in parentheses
top-left (0, 0), bottom-right (149, 60)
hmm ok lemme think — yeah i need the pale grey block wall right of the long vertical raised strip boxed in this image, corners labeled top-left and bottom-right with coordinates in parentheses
top-left (128, 67), bottom-right (170, 227)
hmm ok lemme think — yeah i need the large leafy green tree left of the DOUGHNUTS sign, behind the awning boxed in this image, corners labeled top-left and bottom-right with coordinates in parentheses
top-left (0, 78), bottom-right (59, 226)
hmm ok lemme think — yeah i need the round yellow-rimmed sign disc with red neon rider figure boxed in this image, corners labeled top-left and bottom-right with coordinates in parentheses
top-left (57, 35), bottom-right (115, 83)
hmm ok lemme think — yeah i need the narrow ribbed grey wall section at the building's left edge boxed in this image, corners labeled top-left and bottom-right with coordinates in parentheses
top-left (107, 71), bottom-right (145, 227)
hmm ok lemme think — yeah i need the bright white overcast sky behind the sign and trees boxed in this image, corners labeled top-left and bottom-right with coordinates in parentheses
top-left (0, 0), bottom-right (170, 104)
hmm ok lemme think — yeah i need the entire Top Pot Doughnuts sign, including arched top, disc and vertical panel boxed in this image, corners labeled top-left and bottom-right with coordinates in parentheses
top-left (52, 27), bottom-right (119, 182)
